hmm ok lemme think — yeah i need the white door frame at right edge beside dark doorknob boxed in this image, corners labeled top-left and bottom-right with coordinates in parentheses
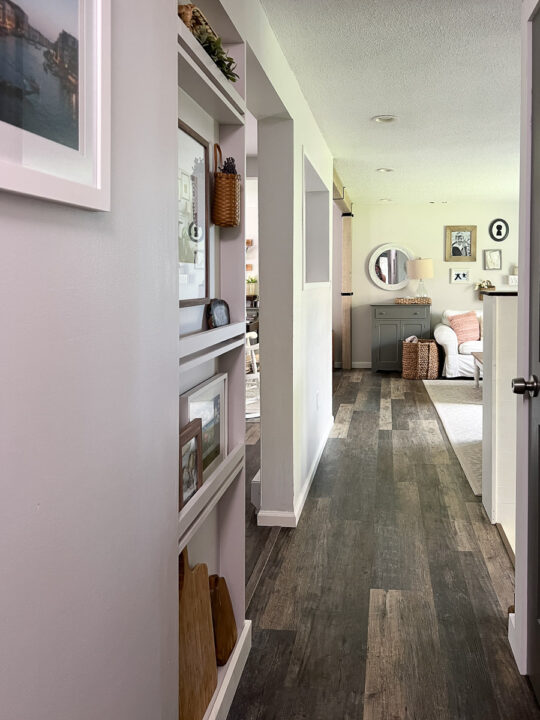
top-left (508, 0), bottom-right (540, 675)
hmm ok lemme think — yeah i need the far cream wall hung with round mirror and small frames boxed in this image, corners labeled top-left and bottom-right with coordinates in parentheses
top-left (352, 199), bottom-right (519, 365)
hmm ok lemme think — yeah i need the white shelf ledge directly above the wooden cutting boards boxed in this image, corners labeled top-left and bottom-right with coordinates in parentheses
top-left (178, 444), bottom-right (245, 551)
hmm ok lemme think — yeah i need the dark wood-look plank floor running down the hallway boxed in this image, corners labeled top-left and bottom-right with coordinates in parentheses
top-left (228, 371), bottom-right (540, 720)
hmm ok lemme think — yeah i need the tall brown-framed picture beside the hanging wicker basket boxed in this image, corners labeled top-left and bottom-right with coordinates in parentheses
top-left (178, 120), bottom-right (210, 307)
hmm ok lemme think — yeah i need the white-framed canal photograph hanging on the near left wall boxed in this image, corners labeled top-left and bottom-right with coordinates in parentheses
top-left (0, 0), bottom-right (111, 210)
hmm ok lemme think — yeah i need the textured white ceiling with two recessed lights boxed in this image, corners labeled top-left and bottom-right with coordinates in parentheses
top-left (261, 0), bottom-right (521, 203)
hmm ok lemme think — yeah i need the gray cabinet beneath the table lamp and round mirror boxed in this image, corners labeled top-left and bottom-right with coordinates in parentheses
top-left (371, 303), bottom-right (431, 372)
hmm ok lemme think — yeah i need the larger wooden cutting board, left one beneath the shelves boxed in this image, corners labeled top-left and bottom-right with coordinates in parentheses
top-left (179, 549), bottom-right (217, 720)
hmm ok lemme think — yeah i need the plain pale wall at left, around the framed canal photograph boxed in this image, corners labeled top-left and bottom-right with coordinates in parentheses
top-left (0, 0), bottom-right (178, 720)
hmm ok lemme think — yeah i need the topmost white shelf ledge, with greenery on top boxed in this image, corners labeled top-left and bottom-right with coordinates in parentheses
top-left (178, 18), bottom-right (246, 125)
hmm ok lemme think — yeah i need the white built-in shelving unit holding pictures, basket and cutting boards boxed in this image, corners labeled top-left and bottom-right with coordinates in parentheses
top-left (177, 0), bottom-right (251, 720)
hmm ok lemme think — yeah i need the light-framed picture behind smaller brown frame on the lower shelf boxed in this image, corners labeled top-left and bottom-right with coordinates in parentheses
top-left (180, 373), bottom-right (228, 481)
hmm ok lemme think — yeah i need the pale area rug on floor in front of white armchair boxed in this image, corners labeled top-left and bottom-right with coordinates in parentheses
top-left (424, 380), bottom-right (482, 495)
